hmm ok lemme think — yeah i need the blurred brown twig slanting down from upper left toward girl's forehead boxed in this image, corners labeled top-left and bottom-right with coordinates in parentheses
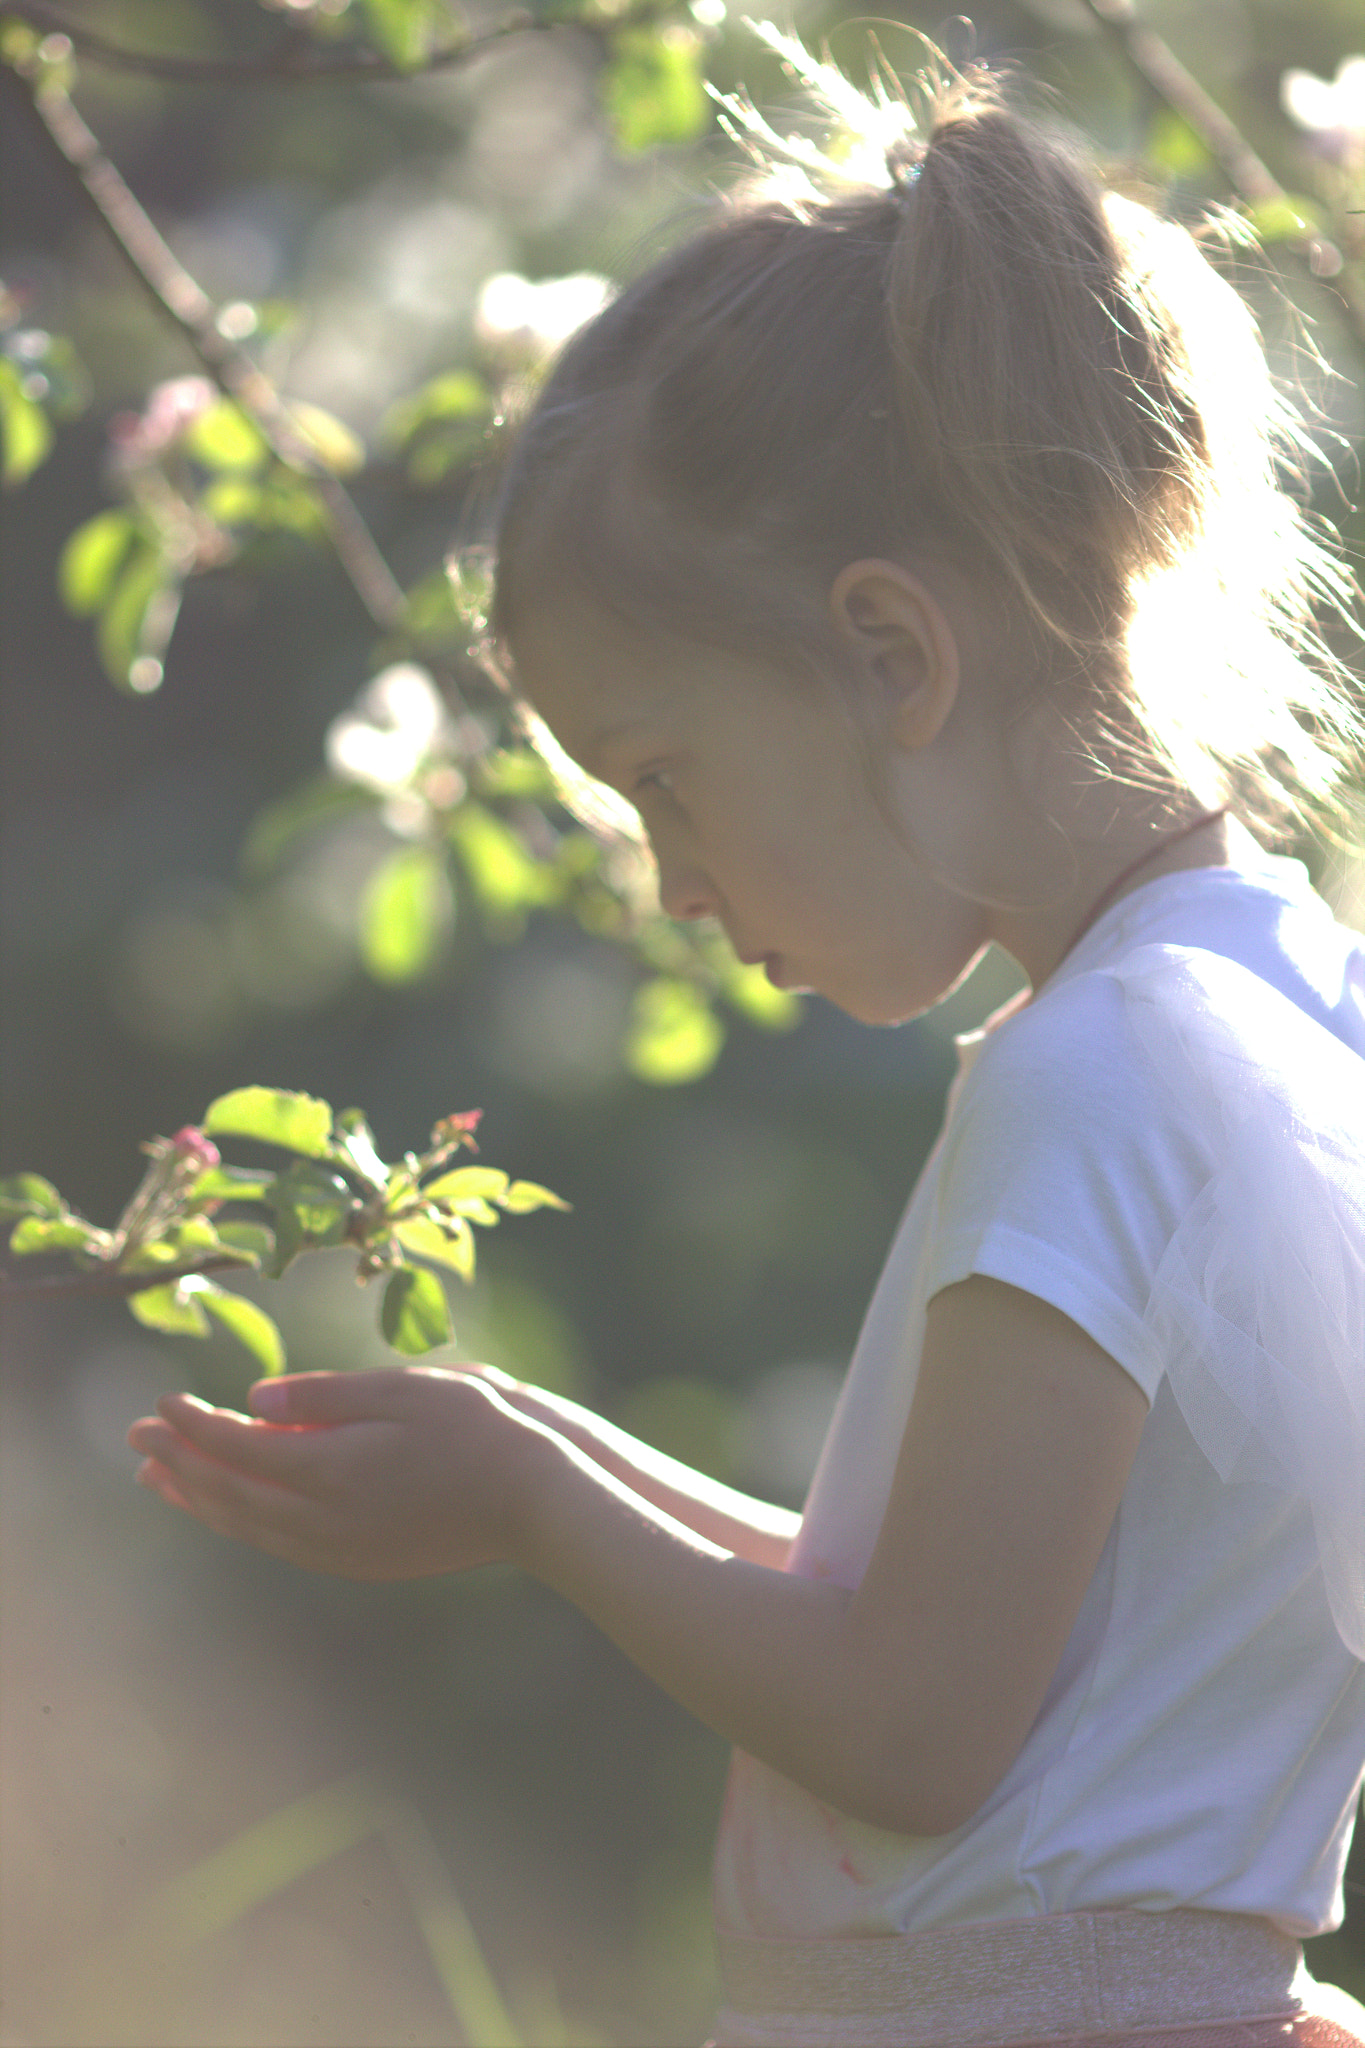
top-left (0, 63), bottom-right (405, 633)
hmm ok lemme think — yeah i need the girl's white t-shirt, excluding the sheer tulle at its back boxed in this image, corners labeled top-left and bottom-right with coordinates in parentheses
top-left (714, 852), bottom-right (1365, 1937)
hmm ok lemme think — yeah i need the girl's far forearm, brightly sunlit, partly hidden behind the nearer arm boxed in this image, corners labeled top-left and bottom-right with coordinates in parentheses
top-left (477, 1366), bottom-right (800, 1571)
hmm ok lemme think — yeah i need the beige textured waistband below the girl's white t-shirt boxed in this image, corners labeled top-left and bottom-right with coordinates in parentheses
top-left (716, 1909), bottom-right (1312, 2048)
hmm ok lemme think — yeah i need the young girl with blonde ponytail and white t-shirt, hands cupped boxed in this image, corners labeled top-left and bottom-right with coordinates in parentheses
top-left (131, 48), bottom-right (1365, 2048)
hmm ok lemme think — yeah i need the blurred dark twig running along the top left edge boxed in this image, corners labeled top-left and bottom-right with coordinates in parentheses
top-left (4, 0), bottom-right (677, 86)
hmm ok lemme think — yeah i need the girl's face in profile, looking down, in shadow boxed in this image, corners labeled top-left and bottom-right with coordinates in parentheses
top-left (516, 608), bottom-right (990, 1024)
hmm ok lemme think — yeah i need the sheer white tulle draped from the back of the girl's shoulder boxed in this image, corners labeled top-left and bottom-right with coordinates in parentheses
top-left (1105, 946), bottom-right (1365, 1659)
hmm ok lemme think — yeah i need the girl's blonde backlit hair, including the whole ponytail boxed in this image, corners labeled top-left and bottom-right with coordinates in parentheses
top-left (493, 33), bottom-right (1365, 823)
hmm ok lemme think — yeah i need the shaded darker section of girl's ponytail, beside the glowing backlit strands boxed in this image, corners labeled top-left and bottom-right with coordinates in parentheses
top-left (886, 84), bottom-right (1207, 645)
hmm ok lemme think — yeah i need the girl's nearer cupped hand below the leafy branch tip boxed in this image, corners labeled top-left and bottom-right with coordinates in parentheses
top-left (129, 1366), bottom-right (542, 1579)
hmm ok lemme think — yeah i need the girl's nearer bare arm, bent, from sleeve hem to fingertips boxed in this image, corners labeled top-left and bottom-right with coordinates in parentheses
top-left (131, 1278), bottom-right (1146, 1835)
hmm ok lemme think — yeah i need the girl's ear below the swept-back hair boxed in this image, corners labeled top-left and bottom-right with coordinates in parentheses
top-left (829, 561), bottom-right (962, 752)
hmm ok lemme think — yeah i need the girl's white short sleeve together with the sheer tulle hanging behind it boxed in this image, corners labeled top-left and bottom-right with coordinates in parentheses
top-left (929, 946), bottom-right (1365, 1659)
